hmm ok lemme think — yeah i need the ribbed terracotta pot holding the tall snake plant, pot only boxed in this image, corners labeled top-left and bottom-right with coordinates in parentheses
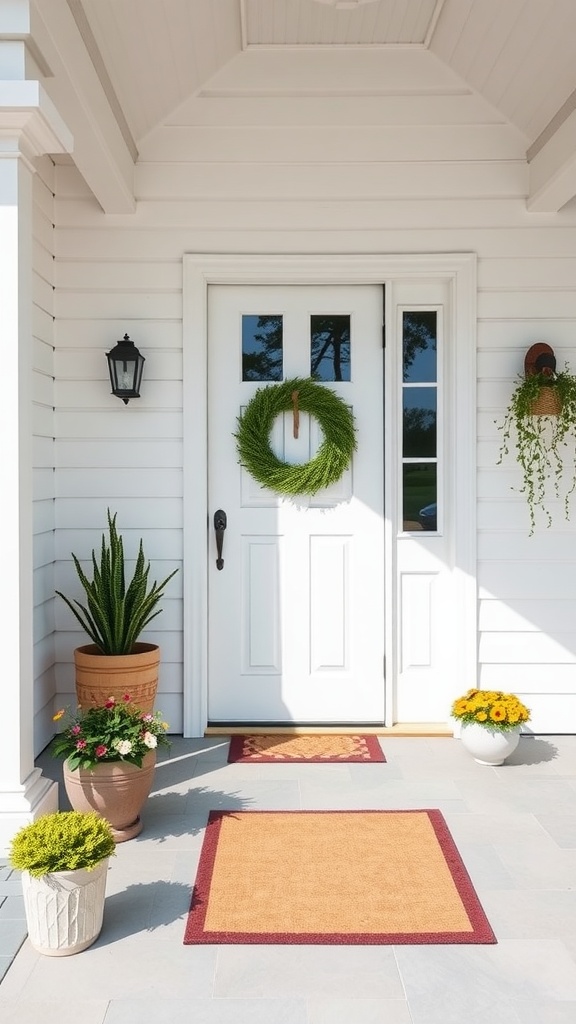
top-left (74, 643), bottom-right (160, 712)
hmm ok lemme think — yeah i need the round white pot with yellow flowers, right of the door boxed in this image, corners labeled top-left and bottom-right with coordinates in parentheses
top-left (451, 690), bottom-right (530, 765)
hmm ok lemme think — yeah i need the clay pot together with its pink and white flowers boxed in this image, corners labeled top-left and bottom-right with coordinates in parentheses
top-left (52, 693), bottom-right (169, 843)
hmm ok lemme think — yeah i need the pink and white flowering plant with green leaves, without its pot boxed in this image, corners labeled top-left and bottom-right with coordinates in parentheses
top-left (52, 693), bottom-right (169, 771)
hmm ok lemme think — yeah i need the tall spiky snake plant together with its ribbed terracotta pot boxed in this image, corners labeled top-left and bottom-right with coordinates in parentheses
top-left (56, 509), bottom-right (178, 711)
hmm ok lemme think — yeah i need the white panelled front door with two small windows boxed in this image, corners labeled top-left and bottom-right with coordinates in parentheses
top-left (203, 285), bottom-right (384, 724)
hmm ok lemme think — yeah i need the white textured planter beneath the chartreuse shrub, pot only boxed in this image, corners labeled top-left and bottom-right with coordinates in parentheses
top-left (22, 857), bottom-right (110, 956)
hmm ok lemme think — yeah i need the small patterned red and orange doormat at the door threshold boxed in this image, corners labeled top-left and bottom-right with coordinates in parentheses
top-left (228, 733), bottom-right (386, 764)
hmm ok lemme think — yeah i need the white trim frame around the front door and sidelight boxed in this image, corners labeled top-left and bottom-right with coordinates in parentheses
top-left (182, 253), bottom-right (478, 736)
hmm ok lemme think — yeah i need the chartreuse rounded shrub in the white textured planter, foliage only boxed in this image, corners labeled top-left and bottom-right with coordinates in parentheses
top-left (8, 811), bottom-right (116, 878)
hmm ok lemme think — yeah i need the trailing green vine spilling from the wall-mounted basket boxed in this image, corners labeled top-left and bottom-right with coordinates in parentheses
top-left (497, 370), bottom-right (576, 536)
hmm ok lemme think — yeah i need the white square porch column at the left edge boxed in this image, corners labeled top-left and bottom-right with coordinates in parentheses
top-left (0, 8), bottom-right (72, 856)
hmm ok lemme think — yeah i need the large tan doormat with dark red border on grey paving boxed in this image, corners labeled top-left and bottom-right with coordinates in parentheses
top-left (183, 809), bottom-right (496, 945)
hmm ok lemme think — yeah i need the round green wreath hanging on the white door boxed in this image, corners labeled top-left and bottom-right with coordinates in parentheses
top-left (234, 377), bottom-right (356, 495)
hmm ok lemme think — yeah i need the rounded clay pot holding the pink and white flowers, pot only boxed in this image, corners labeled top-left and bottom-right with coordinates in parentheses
top-left (64, 751), bottom-right (156, 843)
